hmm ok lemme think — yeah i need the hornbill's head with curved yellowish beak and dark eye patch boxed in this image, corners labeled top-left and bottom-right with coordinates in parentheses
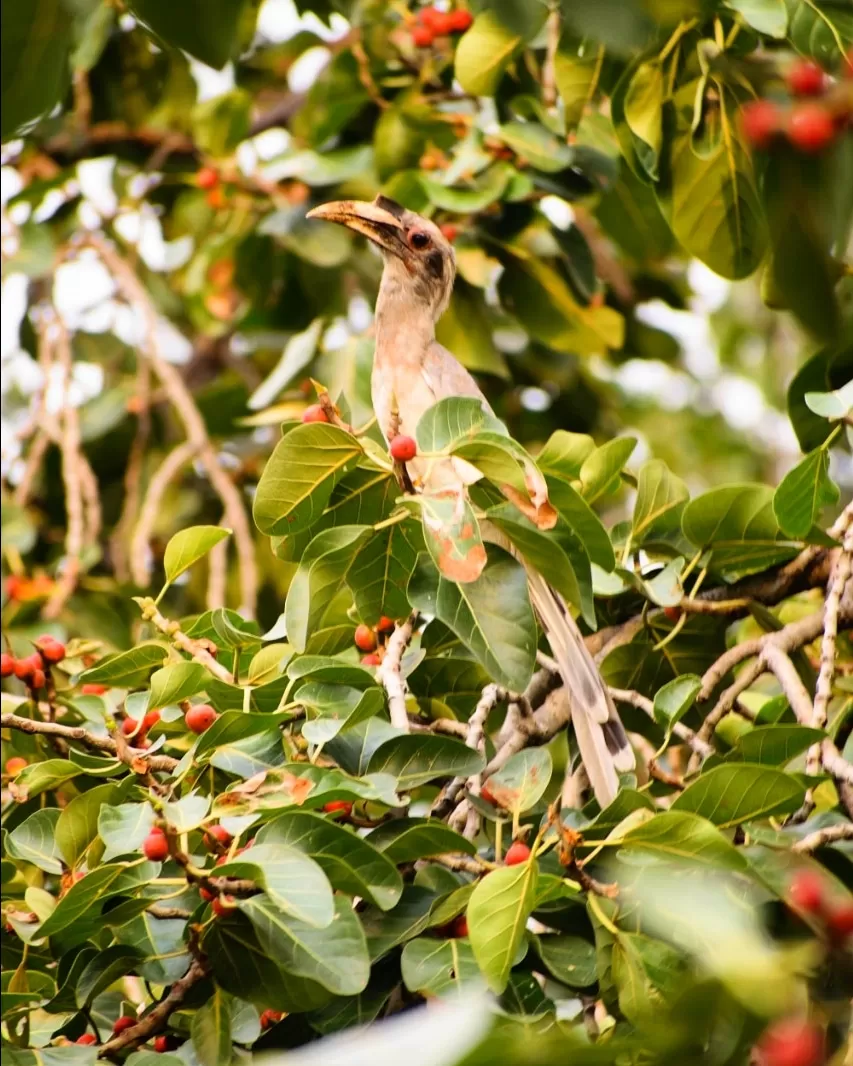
top-left (308, 196), bottom-right (456, 320)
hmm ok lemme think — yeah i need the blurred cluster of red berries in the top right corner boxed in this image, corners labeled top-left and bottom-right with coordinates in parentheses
top-left (741, 53), bottom-right (853, 155)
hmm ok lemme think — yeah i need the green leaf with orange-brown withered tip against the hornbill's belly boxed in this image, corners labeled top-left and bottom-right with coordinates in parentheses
top-left (404, 491), bottom-right (486, 583)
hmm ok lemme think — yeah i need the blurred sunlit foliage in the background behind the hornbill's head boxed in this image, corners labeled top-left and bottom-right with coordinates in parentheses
top-left (2, 0), bottom-right (853, 635)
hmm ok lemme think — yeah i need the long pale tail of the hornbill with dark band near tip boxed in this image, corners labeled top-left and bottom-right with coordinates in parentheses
top-left (525, 563), bottom-right (634, 807)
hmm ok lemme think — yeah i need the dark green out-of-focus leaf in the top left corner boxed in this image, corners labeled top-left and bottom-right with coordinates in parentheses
top-left (0, 0), bottom-right (73, 142)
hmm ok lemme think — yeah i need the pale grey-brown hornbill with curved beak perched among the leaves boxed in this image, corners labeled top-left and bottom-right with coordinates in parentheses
top-left (307, 195), bottom-right (634, 809)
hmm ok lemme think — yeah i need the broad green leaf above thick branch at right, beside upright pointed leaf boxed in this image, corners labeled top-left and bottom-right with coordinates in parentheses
top-left (681, 485), bottom-right (799, 581)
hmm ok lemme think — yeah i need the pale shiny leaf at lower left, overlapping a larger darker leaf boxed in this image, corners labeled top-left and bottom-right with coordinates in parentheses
top-left (216, 838), bottom-right (335, 929)
